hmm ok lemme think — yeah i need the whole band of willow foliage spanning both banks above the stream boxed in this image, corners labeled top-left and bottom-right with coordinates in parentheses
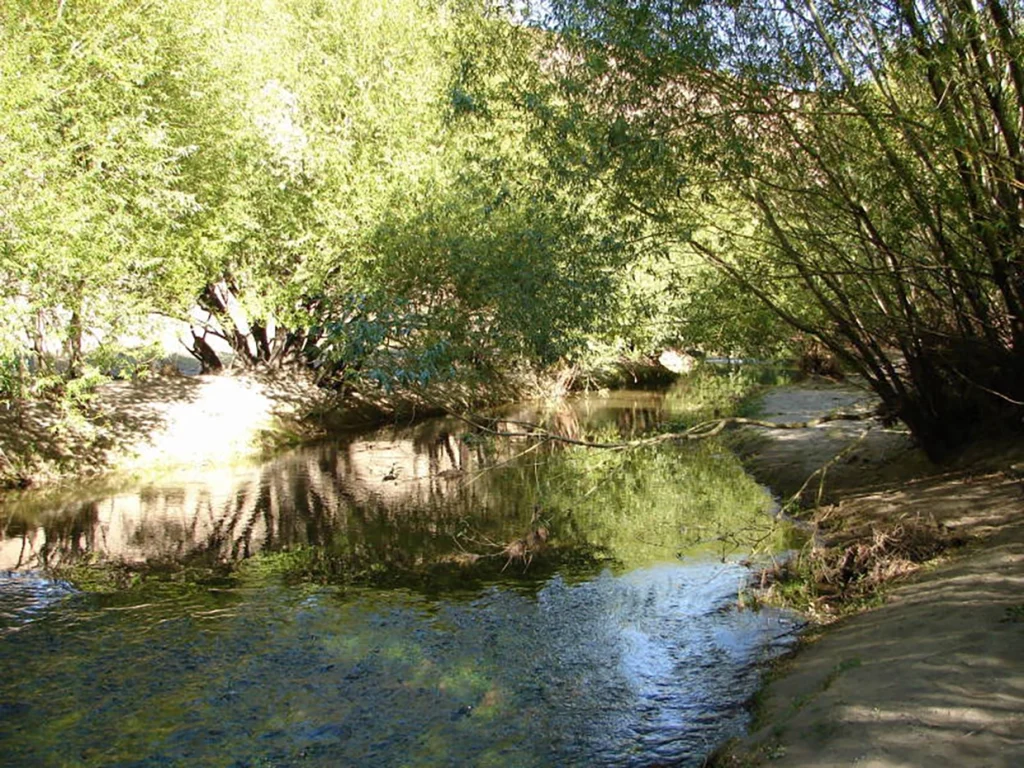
top-left (0, 0), bottom-right (1024, 455)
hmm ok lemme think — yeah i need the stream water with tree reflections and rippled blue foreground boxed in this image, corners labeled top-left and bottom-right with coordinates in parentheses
top-left (0, 392), bottom-right (794, 766)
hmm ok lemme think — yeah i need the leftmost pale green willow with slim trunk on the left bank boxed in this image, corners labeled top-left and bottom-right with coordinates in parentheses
top-left (0, 2), bottom-right (228, 375)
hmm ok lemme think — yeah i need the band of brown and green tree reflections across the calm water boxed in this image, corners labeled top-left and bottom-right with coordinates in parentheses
top-left (0, 402), bottom-right (763, 583)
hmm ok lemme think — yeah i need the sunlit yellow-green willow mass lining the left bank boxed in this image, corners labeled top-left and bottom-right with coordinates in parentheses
top-left (0, 0), bottom-right (623, 397)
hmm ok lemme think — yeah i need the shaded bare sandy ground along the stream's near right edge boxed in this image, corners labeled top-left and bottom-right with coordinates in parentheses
top-left (719, 388), bottom-right (1024, 768)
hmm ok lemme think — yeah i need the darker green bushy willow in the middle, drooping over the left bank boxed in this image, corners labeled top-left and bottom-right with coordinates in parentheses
top-left (307, 9), bottom-right (627, 393)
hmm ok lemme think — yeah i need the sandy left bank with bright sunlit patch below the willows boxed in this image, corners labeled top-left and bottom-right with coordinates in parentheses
top-left (0, 374), bottom-right (348, 486)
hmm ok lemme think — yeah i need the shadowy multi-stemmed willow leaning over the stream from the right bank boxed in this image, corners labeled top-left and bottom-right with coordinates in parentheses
top-left (547, 0), bottom-right (1024, 456)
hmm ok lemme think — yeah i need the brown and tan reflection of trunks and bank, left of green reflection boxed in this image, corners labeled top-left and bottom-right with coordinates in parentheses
top-left (0, 421), bottom-right (544, 581)
